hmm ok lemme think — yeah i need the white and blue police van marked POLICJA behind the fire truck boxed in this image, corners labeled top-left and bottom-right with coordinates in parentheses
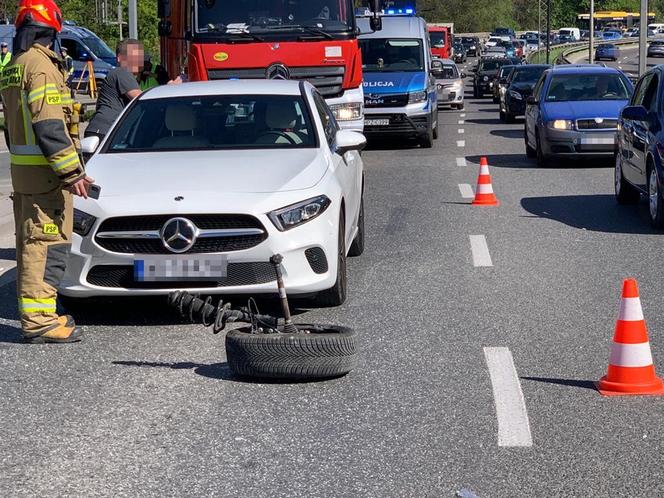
top-left (358, 9), bottom-right (438, 148)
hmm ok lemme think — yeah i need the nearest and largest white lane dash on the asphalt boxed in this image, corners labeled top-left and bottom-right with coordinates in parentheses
top-left (484, 347), bottom-right (533, 446)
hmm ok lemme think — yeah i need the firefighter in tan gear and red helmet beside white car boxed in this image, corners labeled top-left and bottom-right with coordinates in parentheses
top-left (0, 0), bottom-right (93, 343)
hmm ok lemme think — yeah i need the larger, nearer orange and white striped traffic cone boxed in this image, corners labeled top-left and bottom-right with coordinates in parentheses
top-left (598, 278), bottom-right (664, 396)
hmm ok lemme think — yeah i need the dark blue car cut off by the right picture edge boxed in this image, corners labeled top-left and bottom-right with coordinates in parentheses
top-left (615, 66), bottom-right (664, 228)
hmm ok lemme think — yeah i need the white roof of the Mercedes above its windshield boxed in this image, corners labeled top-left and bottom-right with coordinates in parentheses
top-left (140, 80), bottom-right (309, 100)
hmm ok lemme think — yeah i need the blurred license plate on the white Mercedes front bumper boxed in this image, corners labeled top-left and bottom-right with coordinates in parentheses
top-left (134, 255), bottom-right (228, 282)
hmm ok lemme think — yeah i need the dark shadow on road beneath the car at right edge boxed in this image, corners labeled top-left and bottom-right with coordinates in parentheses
top-left (521, 194), bottom-right (661, 235)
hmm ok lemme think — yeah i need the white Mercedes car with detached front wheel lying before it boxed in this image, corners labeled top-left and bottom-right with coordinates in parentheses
top-left (60, 80), bottom-right (366, 306)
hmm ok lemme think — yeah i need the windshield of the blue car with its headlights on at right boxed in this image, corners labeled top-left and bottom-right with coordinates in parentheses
top-left (546, 73), bottom-right (630, 102)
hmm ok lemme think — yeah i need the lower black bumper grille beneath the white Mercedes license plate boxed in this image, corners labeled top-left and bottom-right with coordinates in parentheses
top-left (86, 262), bottom-right (277, 289)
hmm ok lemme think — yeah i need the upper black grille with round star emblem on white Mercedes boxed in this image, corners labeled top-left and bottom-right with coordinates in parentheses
top-left (95, 214), bottom-right (267, 254)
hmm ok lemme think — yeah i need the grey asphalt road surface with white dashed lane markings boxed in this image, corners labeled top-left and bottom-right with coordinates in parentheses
top-left (0, 63), bottom-right (664, 498)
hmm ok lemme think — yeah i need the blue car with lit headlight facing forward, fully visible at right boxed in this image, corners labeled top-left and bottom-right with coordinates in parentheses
top-left (525, 64), bottom-right (633, 167)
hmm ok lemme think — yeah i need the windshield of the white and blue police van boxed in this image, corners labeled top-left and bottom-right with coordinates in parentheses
top-left (360, 38), bottom-right (424, 73)
